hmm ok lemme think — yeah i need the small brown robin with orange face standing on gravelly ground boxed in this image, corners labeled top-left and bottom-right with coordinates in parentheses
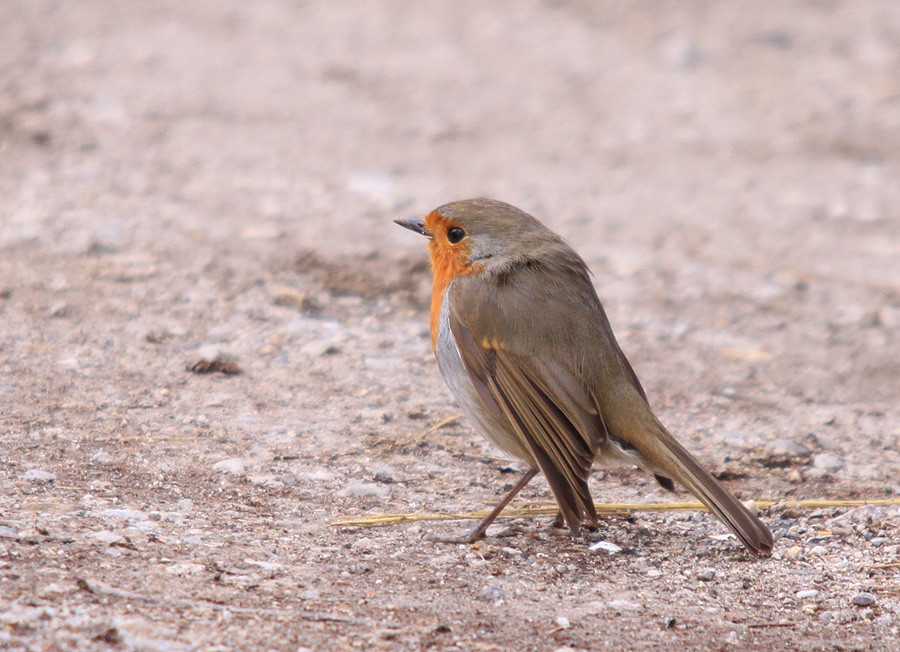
top-left (397, 199), bottom-right (773, 553)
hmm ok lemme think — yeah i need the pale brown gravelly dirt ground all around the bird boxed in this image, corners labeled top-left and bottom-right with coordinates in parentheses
top-left (0, 0), bottom-right (900, 651)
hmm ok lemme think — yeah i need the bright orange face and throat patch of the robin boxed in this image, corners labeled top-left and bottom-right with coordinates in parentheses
top-left (425, 211), bottom-right (481, 349)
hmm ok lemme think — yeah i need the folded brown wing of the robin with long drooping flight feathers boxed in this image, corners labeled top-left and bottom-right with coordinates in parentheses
top-left (450, 303), bottom-right (606, 531)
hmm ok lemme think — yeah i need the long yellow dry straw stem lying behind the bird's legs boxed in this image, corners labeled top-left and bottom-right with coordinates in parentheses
top-left (329, 498), bottom-right (900, 527)
